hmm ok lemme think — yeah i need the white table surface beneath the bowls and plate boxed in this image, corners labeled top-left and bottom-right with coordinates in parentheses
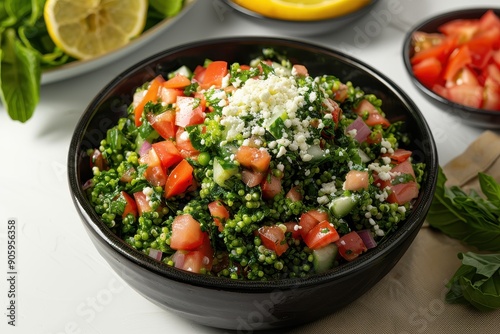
top-left (0, 0), bottom-right (500, 334)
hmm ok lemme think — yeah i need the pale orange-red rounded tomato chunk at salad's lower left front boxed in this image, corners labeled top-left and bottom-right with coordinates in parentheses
top-left (170, 214), bottom-right (204, 250)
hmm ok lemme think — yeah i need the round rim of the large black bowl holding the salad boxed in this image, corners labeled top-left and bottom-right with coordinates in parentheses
top-left (67, 36), bottom-right (438, 292)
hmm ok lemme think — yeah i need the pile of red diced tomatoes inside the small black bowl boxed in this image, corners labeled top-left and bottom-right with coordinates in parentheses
top-left (411, 10), bottom-right (500, 110)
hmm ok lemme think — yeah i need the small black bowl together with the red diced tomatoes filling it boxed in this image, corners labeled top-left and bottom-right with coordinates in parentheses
top-left (403, 8), bottom-right (500, 128)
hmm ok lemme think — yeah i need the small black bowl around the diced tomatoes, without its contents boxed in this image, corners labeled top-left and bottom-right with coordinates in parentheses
top-left (403, 8), bottom-right (500, 129)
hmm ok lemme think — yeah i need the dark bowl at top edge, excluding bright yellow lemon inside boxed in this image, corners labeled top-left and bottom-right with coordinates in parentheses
top-left (223, 0), bottom-right (378, 36)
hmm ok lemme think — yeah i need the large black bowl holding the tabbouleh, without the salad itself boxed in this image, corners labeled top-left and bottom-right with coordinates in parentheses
top-left (68, 37), bottom-right (438, 331)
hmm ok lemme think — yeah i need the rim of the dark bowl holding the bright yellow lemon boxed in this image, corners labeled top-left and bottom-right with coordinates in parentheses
top-left (221, 0), bottom-right (379, 26)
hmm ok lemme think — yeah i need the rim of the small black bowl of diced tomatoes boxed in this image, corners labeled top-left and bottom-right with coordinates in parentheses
top-left (402, 7), bottom-right (500, 117)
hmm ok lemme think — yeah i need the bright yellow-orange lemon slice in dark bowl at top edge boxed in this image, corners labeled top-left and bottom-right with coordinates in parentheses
top-left (233, 0), bottom-right (372, 21)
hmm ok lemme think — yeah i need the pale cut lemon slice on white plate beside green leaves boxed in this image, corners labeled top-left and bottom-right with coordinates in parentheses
top-left (43, 0), bottom-right (148, 59)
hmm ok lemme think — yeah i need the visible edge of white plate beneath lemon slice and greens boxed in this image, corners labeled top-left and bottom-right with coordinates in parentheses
top-left (42, 0), bottom-right (198, 85)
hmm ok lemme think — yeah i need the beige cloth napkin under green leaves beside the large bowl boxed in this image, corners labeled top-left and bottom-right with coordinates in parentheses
top-left (287, 131), bottom-right (500, 334)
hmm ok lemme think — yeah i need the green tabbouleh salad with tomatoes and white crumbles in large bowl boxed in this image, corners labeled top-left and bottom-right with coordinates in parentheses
top-left (85, 49), bottom-right (424, 280)
